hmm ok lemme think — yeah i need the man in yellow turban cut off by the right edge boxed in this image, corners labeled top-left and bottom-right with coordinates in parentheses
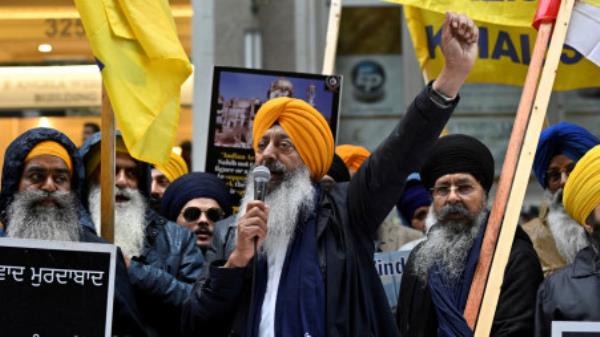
top-left (535, 145), bottom-right (600, 337)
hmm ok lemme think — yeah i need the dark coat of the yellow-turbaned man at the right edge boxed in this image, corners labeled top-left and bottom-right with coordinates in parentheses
top-left (535, 247), bottom-right (600, 337)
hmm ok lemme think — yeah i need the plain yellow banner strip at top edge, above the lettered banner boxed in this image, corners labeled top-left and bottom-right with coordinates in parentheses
top-left (385, 0), bottom-right (536, 27)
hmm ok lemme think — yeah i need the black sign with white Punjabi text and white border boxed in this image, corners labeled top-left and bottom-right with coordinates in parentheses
top-left (0, 238), bottom-right (116, 337)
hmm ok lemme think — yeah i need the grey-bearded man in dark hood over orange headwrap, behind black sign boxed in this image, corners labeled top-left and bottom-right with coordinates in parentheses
top-left (0, 128), bottom-right (146, 336)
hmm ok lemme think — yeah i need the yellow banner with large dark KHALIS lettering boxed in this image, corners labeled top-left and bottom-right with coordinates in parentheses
top-left (404, 7), bottom-right (600, 91)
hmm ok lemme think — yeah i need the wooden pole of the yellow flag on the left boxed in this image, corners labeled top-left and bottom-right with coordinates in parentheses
top-left (100, 86), bottom-right (115, 242)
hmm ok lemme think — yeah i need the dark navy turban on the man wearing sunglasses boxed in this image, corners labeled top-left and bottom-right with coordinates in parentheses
top-left (160, 172), bottom-right (231, 221)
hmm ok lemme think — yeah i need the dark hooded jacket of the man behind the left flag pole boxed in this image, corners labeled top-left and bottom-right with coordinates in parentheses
top-left (80, 133), bottom-right (204, 337)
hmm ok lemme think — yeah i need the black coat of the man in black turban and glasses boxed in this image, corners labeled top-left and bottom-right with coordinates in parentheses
top-left (396, 223), bottom-right (543, 337)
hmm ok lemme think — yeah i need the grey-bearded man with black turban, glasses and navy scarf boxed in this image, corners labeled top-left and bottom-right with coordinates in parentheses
top-left (397, 135), bottom-right (543, 337)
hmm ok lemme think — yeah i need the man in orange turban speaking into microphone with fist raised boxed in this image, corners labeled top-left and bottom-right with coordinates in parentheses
top-left (182, 14), bottom-right (478, 337)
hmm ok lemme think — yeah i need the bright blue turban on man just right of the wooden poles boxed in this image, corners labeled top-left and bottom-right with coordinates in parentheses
top-left (533, 122), bottom-right (600, 188)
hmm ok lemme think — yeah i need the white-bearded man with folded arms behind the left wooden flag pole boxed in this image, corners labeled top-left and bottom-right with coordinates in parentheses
top-left (80, 133), bottom-right (204, 337)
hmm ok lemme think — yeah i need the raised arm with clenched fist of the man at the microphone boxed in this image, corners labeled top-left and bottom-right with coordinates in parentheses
top-left (348, 13), bottom-right (479, 238)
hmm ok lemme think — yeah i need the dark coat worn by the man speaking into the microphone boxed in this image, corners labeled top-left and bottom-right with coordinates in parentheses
top-left (182, 85), bottom-right (455, 337)
